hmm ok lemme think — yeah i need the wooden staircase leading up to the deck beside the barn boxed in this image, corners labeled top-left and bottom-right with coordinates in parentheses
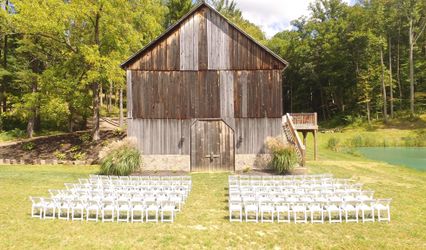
top-left (283, 114), bottom-right (306, 166)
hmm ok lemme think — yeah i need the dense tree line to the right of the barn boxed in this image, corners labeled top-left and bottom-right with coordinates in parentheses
top-left (266, 0), bottom-right (426, 122)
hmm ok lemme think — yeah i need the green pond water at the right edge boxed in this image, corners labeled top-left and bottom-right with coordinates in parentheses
top-left (357, 147), bottom-right (426, 171)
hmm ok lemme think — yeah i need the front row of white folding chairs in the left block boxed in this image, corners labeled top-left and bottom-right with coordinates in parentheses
top-left (30, 197), bottom-right (180, 222)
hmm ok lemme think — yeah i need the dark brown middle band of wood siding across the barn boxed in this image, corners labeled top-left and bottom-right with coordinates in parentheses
top-left (129, 70), bottom-right (282, 119)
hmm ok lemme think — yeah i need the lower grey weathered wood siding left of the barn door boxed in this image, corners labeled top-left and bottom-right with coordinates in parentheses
top-left (128, 119), bottom-right (192, 155)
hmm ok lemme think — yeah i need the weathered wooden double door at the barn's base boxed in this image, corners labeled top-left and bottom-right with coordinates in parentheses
top-left (191, 120), bottom-right (234, 172)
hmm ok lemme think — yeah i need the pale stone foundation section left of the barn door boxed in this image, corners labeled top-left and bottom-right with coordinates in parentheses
top-left (142, 155), bottom-right (191, 172)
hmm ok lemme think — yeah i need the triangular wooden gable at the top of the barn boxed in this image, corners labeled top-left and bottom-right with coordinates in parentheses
top-left (128, 8), bottom-right (284, 70)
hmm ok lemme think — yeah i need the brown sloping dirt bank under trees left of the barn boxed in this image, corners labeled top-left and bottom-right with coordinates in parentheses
top-left (0, 131), bottom-right (126, 163)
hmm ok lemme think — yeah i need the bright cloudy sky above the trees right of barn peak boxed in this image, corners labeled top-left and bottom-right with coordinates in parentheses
top-left (231, 0), bottom-right (354, 38)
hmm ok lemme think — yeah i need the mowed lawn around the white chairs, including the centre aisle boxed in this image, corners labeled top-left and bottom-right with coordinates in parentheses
top-left (0, 159), bottom-right (426, 249)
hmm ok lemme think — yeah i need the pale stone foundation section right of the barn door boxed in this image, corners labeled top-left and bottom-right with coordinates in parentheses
top-left (235, 154), bottom-right (271, 171)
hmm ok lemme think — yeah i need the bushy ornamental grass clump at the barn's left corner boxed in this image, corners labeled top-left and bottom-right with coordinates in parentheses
top-left (99, 138), bottom-right (141, 176)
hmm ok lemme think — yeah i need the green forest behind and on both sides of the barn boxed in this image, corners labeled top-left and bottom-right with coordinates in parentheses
top-left (0, 0), bottom-right (426, 140)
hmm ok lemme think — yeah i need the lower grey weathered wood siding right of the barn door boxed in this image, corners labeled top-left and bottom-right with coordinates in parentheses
top-left (235, 118), bottom-right (282, 154)
